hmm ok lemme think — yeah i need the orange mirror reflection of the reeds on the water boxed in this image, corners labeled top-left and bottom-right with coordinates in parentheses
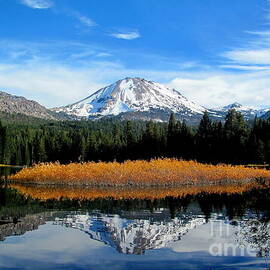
top-left (9, 184), bottom-right (266, 200)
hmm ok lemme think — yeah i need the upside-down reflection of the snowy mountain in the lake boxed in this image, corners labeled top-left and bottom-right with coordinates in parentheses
top-left (54, 214), bottom-right (206, 254)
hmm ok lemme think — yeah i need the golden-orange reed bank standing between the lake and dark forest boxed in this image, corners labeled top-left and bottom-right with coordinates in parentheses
top-left (7, 159), bottom-right (270, 187)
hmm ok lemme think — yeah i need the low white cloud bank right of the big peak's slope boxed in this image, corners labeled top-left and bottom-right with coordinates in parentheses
top-left (168, 71), bottom-right (270, 108)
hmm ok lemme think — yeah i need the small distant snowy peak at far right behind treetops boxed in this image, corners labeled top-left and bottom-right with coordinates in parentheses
top-left (212, 102), bottom-right (270, 119)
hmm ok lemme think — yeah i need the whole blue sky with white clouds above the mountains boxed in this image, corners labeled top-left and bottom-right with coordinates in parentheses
top-left (0, 0), bottom-right (270, 107)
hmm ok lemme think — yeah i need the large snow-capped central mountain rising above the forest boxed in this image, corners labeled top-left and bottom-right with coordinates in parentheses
top-left (54, 78), bottom-right (206, 120)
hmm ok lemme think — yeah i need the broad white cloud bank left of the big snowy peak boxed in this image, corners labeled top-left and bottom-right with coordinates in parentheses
top-left (0, 60), bottom-right (103, 107)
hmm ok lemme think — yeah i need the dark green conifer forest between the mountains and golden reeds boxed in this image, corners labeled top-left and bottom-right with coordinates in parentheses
top-left (0, 110), bottom-right (270, 165)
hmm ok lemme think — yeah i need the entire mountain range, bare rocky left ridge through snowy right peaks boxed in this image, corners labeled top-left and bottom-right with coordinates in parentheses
top-left (0, 78), bottom-right (270, 125)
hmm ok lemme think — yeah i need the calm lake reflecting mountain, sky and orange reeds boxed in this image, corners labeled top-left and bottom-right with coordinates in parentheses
top-left (0, 172), bottom-right (270, 270)
